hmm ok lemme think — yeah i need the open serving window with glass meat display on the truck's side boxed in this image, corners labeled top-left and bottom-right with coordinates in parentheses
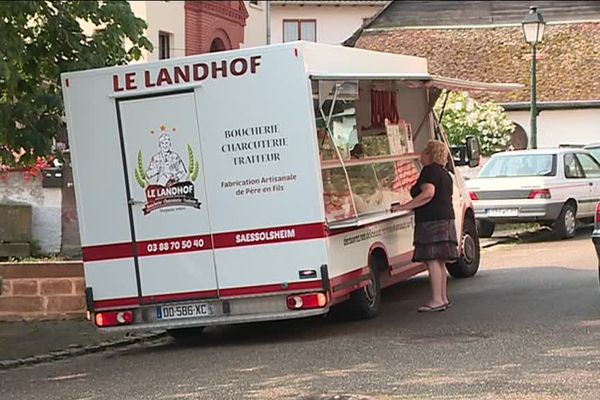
top-left (312, 80), bottom-right (421, 222)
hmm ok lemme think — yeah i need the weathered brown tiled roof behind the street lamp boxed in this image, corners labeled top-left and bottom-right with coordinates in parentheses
top-left (356, 22), bottom-right (600, 103)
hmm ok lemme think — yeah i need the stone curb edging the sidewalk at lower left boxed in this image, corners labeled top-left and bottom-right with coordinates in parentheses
top-left (0, 331), bottom-right (167, 371)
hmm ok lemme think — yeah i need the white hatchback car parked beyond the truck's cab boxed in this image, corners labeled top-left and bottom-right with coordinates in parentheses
top-left (466, 148), bottom-right (600, 238)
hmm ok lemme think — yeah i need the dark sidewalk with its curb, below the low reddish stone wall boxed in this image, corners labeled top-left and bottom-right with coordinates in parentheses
top-left (0, 320), bottom-right (164, 370)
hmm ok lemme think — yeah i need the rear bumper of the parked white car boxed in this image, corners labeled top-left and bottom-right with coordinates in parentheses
top-left (473, 199), bottom-right (563, 222)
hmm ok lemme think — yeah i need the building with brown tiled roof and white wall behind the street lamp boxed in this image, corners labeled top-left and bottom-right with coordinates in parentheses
top-left (345, 1), bottom-right (600, 147)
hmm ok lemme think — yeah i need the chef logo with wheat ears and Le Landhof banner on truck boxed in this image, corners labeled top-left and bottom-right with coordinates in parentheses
top-left (135, 125), bottom-right (201, 214)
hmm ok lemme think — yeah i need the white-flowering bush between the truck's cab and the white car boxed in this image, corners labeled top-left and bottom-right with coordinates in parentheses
top-left (435, 92), bottom-right (515, 155)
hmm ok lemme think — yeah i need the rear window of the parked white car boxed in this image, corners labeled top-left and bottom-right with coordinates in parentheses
top-left (479, 154), bottom-right (556, 178)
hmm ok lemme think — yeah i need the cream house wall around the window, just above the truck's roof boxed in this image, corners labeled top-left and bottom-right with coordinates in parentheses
top-left (271, 5), bottom-right (380, 44)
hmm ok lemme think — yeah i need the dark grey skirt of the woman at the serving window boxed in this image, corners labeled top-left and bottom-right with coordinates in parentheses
top-left (413, 220), bottom-right (458, 262)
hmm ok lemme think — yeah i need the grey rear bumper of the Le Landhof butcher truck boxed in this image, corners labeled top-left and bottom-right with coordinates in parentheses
top-left (98, 293), bottom-right (329, 333)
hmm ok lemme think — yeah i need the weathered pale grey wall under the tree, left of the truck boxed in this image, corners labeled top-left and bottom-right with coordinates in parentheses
top-left (0, 171), bottom-right (62, 254)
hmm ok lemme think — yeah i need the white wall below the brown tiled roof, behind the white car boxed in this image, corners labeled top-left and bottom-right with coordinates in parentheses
top-left (507, 108), bottom-right (600, 148)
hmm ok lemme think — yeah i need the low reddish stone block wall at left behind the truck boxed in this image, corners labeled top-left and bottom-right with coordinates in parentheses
top-left (0, 262), bottom-right (86, 321)
